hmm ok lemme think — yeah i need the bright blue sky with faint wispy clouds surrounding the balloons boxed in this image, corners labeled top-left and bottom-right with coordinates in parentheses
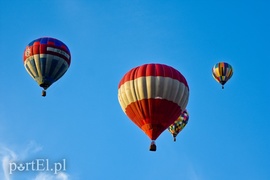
top-left (0, 0), bottom-right (270, 180)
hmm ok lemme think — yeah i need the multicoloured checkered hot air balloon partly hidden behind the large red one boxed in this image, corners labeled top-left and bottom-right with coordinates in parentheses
top-left (168, 110), bottom-right (189, 141)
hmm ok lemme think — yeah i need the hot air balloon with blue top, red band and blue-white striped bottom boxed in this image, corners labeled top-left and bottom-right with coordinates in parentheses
top-left (23, 37), bottom-right (71, 96)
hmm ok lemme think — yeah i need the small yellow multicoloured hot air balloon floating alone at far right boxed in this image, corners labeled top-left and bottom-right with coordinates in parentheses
top-left (212, 62), bottom-right (233, 89)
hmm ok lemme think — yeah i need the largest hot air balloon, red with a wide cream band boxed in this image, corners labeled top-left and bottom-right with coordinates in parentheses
top-left (118, 64), bottom-right (189, 151)
